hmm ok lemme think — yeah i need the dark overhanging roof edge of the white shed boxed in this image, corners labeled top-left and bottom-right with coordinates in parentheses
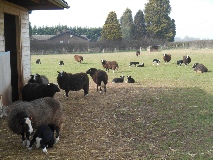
top-left (3, 0), bottom-right (69, 11)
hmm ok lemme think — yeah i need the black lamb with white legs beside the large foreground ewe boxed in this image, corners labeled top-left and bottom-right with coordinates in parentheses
top-left (28, 125), bottom-right (55, 153)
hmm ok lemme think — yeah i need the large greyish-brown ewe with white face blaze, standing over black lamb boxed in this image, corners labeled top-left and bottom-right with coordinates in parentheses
top-left (8, 97), bottom-right (63, 146)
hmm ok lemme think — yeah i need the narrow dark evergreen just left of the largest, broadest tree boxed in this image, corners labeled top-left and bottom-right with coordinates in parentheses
top-left (134, 10), bottom-right (146, 40)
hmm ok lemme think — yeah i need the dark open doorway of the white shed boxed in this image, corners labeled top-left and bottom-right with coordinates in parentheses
top-left (4, 14), bottom-right (19, 102)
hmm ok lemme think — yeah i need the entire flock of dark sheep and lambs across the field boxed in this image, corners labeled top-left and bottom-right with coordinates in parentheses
top-left (0, 51), bottom-right (208, 153)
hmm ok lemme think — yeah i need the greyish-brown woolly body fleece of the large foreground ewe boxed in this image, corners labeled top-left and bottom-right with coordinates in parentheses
top-left (8, 97), bottom-right (63, 134)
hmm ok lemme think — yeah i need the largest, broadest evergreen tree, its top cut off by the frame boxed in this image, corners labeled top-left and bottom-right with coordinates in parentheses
top-left (144, 0), bottom-right (175, 41)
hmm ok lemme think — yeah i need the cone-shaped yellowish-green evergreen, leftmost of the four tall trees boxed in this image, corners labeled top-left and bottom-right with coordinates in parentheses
top-left (101, 11), bottom-right (122, 41)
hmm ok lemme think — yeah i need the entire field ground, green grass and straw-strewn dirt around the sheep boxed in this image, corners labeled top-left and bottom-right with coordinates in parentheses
top-left (0, 49), bottom-right (213, 160)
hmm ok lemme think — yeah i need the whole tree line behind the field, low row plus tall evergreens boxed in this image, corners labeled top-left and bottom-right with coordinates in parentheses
top-left (29, 0), bottom-right (176, 42)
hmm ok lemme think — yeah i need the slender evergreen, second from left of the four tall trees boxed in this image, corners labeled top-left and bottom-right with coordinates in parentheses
top-left (120, 8), bottom-right (134, 41)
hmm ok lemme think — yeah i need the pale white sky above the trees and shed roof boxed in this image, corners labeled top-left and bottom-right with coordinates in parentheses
top-left (30, 0), bottom-right (213, 39)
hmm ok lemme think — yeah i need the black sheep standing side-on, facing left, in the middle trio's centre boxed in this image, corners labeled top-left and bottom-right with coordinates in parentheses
top-left (57, 71), bottom-right (89, 98)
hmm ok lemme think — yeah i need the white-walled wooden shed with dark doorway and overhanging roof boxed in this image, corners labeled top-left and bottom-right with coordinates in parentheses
top-left (0, 0), bottom-right (69, 105)
